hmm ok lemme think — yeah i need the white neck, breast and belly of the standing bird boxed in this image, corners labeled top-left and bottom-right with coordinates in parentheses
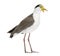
top-left (21, 7), bottom-right (40, 33)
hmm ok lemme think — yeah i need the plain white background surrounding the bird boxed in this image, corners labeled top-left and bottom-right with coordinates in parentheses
top-left (0, 0), bottom-right (60, 56)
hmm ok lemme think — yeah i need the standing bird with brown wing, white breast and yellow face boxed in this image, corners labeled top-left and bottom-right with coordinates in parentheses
top-left (8, 4), bottom-right (47, 53)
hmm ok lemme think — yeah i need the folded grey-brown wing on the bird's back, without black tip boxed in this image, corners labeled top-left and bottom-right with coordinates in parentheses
top-left (14, 14), bottom-right (34, 33)
